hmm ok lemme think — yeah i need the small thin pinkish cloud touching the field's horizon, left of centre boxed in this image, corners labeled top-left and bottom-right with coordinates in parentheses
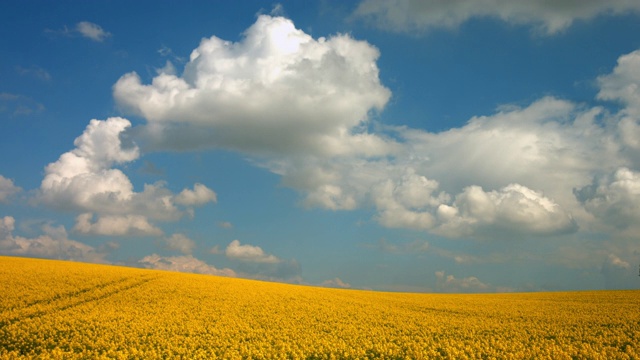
top-left (138, 254), bottom-right (236, 277)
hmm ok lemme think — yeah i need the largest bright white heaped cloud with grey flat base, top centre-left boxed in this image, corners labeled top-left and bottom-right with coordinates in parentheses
top-left (113, 15), bottom-right (392, 154)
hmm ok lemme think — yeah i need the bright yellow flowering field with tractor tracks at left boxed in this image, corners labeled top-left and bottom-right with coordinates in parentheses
top-left (0, 257), bottom-right (640, 359)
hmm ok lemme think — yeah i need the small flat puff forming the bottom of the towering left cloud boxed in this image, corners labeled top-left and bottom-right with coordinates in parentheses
top-left (73, 213), bottom-right (162, 236)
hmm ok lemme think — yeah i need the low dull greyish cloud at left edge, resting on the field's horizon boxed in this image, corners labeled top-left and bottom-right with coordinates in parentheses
top-left (0, 216), bottom-right (106, 263)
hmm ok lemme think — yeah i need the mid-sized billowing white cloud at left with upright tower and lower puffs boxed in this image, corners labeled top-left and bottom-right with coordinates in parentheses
top-left (38, 117), bottom-right (215, 236)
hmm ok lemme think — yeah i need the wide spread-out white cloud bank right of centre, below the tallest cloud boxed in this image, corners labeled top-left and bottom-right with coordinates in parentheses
top-left (269, 97), bottom-right (628, 237)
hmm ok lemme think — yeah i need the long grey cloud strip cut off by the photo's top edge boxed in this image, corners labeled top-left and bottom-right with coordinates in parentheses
top-left (354, 0), bottom-right (640, 35)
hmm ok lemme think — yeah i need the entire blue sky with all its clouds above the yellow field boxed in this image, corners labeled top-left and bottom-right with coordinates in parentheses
top-left (0, 0), bottom-right (640, 293)
